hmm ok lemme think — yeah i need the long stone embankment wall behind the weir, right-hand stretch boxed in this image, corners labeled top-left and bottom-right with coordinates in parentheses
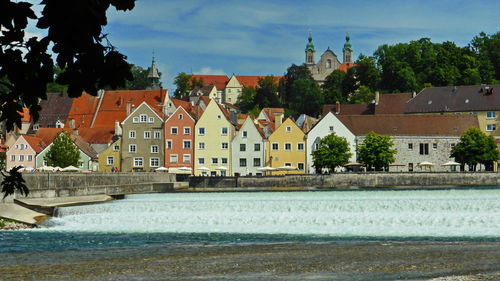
top-left (189, 172), bottom-right (500, 188)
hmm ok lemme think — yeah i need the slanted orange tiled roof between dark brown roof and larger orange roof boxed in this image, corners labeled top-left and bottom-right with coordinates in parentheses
top-left (64, 93), bottom-right (99, 128)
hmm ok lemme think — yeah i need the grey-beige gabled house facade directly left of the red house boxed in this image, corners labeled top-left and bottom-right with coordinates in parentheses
top-left (120, 102), bottom-right (165, 172)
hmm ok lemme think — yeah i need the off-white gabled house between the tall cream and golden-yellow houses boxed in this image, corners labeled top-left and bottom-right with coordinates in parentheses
top-left (231, 117), bottom-right (266, 176)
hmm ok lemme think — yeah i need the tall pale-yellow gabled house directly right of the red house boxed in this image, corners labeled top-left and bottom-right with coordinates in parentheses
top-left (193, 100), bottom-right (235, 176)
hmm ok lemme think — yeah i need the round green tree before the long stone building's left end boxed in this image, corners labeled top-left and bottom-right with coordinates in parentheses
top-left (357, 132), bottom-right (396, 171)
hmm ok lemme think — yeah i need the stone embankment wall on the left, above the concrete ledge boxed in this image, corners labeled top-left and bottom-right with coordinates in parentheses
top-left (5, 172), bottom-right (176, 202)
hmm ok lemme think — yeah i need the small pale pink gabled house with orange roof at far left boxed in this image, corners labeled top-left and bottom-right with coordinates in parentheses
top-left (6, 135), bottom-right (45, 170)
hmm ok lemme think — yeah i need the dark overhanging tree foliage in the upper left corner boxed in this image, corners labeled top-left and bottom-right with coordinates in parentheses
top-left (0, 0), bottom-right (135, 130)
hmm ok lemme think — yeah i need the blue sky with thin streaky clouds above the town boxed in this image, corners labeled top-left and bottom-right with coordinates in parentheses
top-left (30, 0), bottom-right (500, 92)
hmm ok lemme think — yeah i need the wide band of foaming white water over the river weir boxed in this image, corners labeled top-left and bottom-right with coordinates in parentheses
top-left (41, 190), bottom-right (500, 238)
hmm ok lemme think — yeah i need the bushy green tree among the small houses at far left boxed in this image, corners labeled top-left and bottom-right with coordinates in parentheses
top-left (43, 131), bottom-right (81, 168)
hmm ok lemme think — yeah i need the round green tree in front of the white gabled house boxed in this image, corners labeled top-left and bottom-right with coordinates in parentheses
top-left (312, 133), bottom-right (352, 173)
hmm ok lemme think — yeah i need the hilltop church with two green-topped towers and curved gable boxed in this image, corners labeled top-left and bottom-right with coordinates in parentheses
top-left (305, 34), bottom-right (355, 84)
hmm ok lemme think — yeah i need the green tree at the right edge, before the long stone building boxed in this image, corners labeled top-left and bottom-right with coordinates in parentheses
top-left (451, 127), bottom-right (500, 171)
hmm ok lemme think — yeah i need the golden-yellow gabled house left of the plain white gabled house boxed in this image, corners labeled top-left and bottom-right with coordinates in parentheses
top-left (266, 118), bottom-right (306, 175)
